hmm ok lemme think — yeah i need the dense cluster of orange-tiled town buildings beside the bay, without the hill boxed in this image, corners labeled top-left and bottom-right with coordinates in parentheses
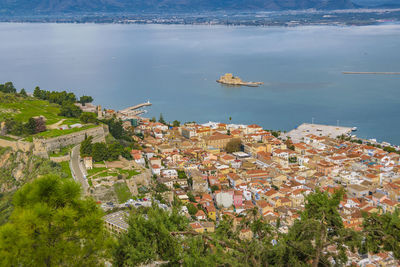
top-left (97, 104), bottom-right (400, 266)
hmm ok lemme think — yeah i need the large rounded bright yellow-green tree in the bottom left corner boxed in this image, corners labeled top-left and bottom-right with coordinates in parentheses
top-left (0, 175), bottom-right (107, 266)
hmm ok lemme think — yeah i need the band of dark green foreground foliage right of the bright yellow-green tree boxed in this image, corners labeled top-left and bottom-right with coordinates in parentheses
top-left (113, 191), bottom-right (400, 266)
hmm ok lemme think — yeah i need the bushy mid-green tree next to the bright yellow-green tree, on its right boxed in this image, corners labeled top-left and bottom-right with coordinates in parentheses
top-left (113, 205), bottom-right (187, 266)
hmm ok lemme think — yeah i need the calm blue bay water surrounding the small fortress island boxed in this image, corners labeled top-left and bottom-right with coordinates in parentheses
top-left (0, 23), bottom-right (400, 144)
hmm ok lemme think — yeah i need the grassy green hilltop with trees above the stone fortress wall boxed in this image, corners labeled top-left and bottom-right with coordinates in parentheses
top-left (0, 82), bottom-right (98, 141)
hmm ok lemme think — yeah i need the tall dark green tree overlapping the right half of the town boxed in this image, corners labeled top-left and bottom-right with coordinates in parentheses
top-left (278, 190), bottom-right (360, 266)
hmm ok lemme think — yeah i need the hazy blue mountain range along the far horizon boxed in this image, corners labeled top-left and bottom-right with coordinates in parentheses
top-left (0, 0), bottom-right (398, 15)
